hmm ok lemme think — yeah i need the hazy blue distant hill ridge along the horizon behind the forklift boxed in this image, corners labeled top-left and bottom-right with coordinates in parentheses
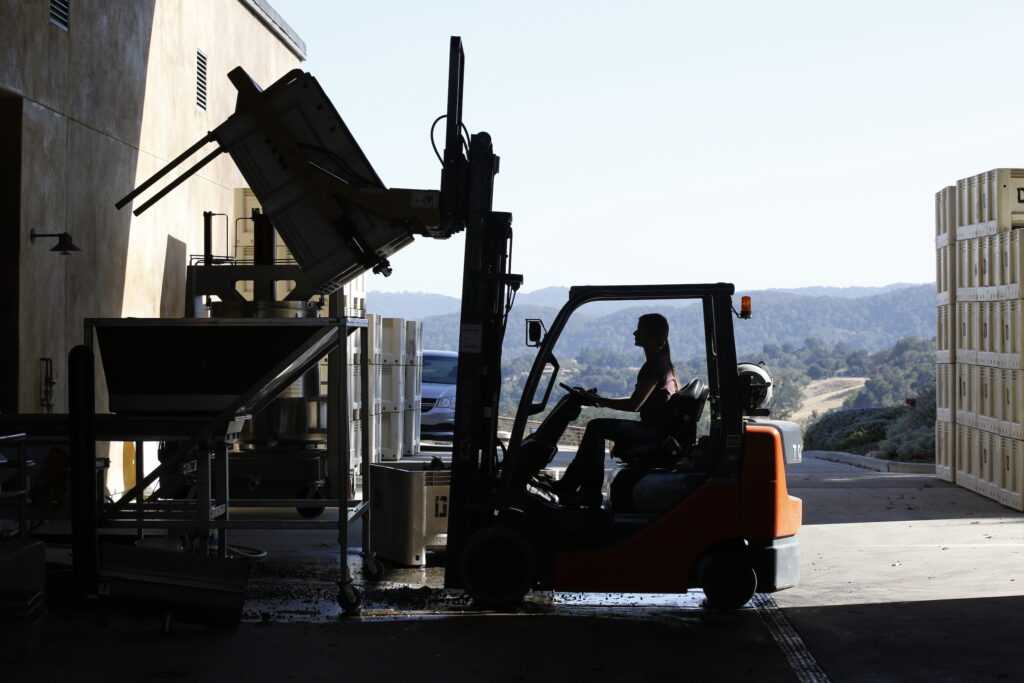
top-left (413, 285), bottom-right (935, 359)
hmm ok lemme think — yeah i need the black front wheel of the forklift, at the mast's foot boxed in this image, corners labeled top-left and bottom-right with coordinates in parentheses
top-left (460, 526), bottom-right (537, 609)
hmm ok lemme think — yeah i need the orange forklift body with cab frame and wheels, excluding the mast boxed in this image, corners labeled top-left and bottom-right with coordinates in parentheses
top-left (445, 283), bottom-right (803, 609)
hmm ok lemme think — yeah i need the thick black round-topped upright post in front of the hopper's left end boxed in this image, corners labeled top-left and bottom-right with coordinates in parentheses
top-left (68, 346), bottom-right (99, 595)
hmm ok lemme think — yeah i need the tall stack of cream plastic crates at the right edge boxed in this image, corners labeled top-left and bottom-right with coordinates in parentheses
top-left (936, 169), bottom-right (1024, 510)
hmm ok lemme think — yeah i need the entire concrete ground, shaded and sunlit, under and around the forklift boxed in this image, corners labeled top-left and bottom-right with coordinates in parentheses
top-left (8, 450), bottom-right (1024, 683)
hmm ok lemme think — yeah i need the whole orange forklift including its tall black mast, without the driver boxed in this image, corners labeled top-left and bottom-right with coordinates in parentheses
top-left (440, 38), bottom-right (803, 609)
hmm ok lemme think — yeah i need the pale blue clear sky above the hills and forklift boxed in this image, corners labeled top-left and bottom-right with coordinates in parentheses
top-left (272, 0), bottom-right (1024, 296)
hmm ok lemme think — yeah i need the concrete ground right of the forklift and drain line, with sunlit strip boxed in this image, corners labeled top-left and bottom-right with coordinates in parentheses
top-left (775, 456), bottom-right (1024, 681)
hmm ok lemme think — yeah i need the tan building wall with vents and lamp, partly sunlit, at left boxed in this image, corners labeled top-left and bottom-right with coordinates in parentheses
top-left (0, 0), bottom-right (300, 413)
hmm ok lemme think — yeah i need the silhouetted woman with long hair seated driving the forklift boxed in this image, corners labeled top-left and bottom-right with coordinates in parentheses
top-left (554, 313), bottom-right (679, 507)
